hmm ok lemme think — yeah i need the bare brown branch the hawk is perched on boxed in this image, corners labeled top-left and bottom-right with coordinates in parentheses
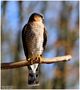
top-left (1, 55), bottom-right (72, 69)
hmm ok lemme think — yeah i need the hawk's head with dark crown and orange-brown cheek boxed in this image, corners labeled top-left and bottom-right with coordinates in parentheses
top-left (29, 13), bottom-right (44, 22)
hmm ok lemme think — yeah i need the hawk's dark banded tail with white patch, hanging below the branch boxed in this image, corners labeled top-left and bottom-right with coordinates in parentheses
top-left (28, 64), bottom-right (40, 85)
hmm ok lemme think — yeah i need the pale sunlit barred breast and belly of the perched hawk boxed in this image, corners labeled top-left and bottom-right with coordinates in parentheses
top-left (31, 22), bottom-right (44, 55)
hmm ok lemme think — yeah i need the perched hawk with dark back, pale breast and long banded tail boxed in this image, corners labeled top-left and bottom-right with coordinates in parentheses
top-left (22, 13), bottom-right (47, 85)
